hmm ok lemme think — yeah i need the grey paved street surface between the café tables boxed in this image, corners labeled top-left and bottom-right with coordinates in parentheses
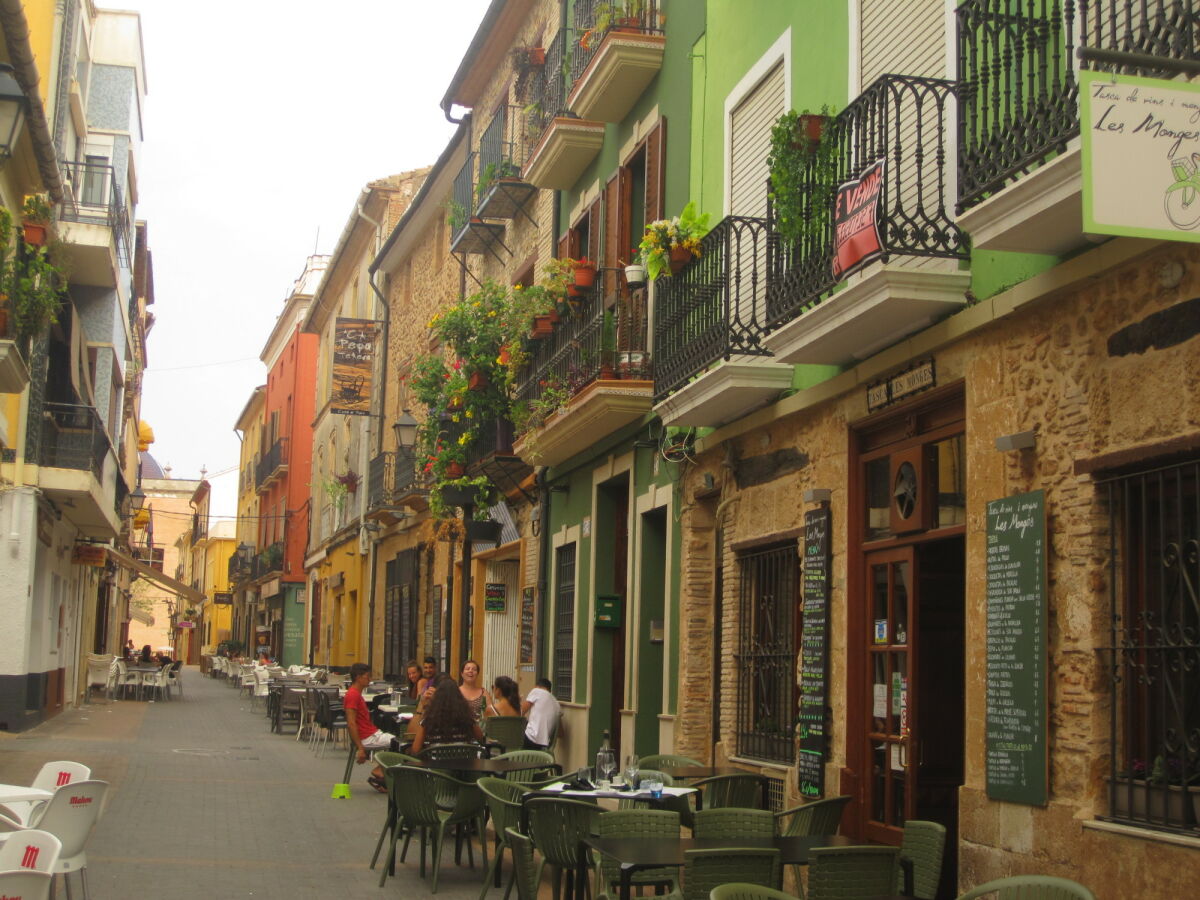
top-left (0, 668), bottom-right (535, 900)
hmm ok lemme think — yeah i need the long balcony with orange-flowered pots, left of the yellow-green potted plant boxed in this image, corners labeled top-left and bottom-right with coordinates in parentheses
top-left (512, 259), bottom-right (654, 466)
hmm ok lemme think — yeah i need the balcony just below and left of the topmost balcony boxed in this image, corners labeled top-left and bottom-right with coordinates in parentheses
top-left (522, 31), bottom-right (605, 191)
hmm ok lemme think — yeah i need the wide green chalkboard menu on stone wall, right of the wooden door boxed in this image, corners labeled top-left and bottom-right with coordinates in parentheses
top-left (986, 491), bottom-right (1046, 806)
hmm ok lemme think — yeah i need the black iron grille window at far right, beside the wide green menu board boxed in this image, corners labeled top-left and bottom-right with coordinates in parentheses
top-left (1103, 458), bottom-right (1200, 833)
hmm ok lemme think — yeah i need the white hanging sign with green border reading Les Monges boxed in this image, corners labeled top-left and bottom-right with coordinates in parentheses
top-left (1079, 71), bottom-right (1200, 241)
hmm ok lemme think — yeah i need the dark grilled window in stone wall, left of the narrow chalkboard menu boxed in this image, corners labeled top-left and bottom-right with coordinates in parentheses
top-left (737, 541), bottom-right (800, 762)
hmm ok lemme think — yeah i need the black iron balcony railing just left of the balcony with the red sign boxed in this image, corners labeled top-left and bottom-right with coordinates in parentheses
top-left (654, 216), bottom-right (768, 402)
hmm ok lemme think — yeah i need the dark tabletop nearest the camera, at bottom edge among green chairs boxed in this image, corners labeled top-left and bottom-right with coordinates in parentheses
top-left (576, 834), bottom-right (862, 900)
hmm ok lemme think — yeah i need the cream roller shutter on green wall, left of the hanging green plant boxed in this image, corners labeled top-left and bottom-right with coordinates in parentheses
top-left (730, 62), bottom-right (787, 216)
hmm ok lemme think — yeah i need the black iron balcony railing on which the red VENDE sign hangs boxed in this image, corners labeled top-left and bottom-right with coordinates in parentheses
top-left (767, 74), bottom-right (968, 329)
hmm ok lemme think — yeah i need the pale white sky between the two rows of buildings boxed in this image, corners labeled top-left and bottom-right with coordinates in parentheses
top-left (129, 0), bottom-right (487, 515)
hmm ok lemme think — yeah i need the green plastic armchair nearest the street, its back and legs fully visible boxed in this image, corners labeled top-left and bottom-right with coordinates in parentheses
top-left (379, 766), bottom-right (487, 894)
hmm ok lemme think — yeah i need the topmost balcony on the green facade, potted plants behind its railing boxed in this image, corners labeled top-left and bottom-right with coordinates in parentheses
top-left (566, 0), bottom-right (666, 122)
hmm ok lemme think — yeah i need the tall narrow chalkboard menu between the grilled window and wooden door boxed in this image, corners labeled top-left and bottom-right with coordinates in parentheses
top-left (797, 508), bottom-right (830, 800)
